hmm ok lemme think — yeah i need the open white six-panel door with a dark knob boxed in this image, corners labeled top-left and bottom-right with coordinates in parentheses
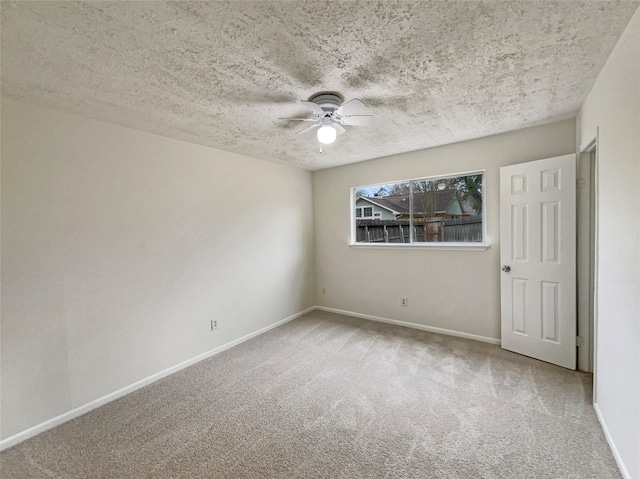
top-left (500, 155), bottom-right (576, 369)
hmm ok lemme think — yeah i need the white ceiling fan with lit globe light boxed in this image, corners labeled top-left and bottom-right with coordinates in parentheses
top-left (280, 92), bottom-right (373, 145)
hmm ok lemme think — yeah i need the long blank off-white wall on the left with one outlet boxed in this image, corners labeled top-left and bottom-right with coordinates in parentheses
top-left (1, 99), bottom-right (314, 438)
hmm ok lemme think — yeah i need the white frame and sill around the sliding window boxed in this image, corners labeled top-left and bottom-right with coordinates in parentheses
top-left (349, 169), bottom-right (491, 251)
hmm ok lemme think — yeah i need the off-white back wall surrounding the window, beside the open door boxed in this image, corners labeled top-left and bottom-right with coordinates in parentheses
top-left (313, 120), bottom-right (575, 339)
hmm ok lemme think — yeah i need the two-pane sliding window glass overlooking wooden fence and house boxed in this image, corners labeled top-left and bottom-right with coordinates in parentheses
top-left (352, 171), bottom-right (485, 244)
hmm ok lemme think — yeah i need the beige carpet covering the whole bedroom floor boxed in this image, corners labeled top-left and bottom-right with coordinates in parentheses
top-left (0, 311), bottom-right (620, 479)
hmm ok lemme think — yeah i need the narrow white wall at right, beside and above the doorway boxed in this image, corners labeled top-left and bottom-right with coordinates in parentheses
top-left (577, 10), bottom-right (640, 478)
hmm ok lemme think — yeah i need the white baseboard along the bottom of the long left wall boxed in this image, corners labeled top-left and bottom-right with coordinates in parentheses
top-left (0, 306), bottom-right (315, 451)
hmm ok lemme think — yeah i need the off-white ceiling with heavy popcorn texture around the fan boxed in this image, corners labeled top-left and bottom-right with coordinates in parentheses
top-left (1, 0), bottom-right (638, 169)
